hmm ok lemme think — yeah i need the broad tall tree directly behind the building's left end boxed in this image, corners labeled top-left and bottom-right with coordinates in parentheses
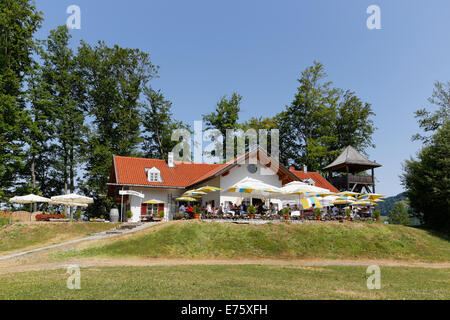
top-left (78, 42), bottom-right (157, 213)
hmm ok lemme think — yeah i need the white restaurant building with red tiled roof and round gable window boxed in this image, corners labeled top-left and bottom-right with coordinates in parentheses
top-left (108, 149), bottom-right (336, 221)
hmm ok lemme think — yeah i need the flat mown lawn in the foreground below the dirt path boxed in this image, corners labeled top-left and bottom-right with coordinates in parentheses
top-left (0, 265), bottom-right (450, 299)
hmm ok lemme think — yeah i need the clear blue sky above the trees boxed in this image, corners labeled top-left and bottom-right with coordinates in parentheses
top-left (36, 0), bottom-right (450, 195)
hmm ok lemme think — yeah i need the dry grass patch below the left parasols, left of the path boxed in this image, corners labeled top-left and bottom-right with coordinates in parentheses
top-left (0, 222), bottom-right (116, 253)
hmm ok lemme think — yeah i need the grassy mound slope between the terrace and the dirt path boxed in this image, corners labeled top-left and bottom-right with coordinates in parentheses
top-left (58, 222), bottom-right (450, 262)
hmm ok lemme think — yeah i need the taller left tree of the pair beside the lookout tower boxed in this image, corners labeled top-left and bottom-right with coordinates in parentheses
top-left (277, 62), bottom-right (339, 170)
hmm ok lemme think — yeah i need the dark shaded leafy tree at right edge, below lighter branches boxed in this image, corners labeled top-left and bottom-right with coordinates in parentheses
top-left (402, 121), bottom-right (450, 231)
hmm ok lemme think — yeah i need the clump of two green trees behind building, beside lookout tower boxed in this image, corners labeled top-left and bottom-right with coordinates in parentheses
top-left (276, 62), bottom-right (375, 171)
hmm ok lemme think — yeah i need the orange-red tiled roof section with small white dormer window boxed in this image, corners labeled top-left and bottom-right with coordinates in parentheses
top-left (111, 156), bottom-right (226, 188)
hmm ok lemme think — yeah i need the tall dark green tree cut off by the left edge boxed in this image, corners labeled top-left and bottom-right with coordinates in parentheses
top-left (0, 0), bottom-right (42, 201)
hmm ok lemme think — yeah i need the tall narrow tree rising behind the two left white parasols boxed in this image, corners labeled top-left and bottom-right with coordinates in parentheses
top-left (41, 26), bottom-right (85, 205)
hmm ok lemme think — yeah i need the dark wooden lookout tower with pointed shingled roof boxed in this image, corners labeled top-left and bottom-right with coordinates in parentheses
top-left (323, 146), bottom-right (381, 193)
